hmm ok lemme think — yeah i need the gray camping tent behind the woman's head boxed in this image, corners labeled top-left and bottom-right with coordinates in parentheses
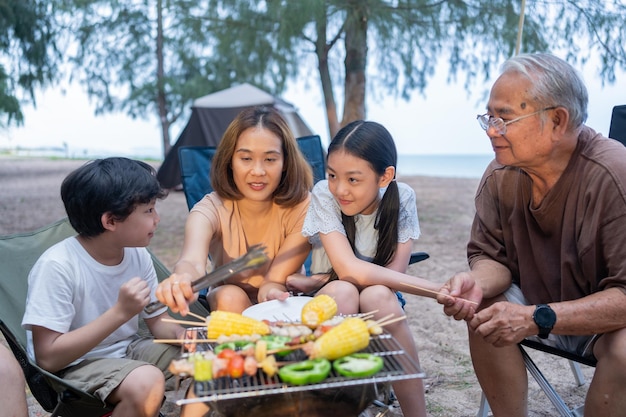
top-left (157, 84), bottom-right (313, 188)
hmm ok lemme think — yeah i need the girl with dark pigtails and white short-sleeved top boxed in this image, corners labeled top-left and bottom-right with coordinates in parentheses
top-left (288, 121), bottom-right (440, 416)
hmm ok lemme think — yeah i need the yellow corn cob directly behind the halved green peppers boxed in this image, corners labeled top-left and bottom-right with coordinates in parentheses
top-left (309, 317), bottom-right (370, 360)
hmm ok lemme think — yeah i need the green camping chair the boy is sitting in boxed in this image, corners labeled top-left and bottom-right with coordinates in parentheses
top-left (0, 218), bottom-right (208, 417)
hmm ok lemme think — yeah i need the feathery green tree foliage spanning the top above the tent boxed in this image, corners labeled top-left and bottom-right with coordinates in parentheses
top-left (7, 0), bottom-right (626, 153)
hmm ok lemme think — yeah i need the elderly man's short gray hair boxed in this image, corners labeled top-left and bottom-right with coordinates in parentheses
top-left (501, 53), bottom-right (589, 129)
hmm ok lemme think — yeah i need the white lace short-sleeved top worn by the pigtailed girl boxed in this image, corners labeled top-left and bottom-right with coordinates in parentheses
top-left (302, 180), bottom-right (420, 274)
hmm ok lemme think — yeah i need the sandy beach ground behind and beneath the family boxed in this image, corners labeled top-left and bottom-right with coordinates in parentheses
top-left (0, 156), bottom-right (593, 417)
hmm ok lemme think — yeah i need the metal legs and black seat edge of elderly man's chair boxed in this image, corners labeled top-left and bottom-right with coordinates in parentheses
top-left (476, 339), bottom-right (596, 417)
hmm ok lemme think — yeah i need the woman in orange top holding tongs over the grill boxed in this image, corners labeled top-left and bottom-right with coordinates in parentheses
top-left (157, 107), bottom-right (313, 315)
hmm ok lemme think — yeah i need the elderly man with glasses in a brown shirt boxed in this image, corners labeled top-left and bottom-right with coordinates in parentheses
top-left (439, 54), bottom-right (626, 417)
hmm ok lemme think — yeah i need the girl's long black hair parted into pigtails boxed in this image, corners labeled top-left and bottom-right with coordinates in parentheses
top-left (327, 120), bottom-right (400, 279)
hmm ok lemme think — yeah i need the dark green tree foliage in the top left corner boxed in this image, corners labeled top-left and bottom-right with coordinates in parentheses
top-left (0, 0), bottom-right (58, 126)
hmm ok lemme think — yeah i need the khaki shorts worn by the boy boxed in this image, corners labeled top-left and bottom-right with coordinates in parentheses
top-left (59, 338), bottom-right (180, 403)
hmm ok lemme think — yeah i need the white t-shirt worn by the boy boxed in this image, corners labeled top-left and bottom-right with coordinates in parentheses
top-left (22, 237), bottom-right (165, 365)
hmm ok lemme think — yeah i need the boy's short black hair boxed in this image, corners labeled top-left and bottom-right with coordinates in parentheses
top-left (61, 157), bottom-right (167, 237)
